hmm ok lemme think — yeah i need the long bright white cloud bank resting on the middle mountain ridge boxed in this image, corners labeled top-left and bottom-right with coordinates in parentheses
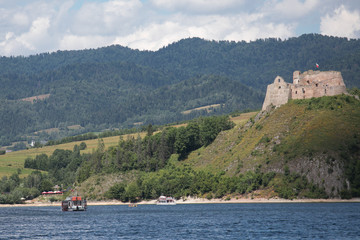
top-left (113, 14), bottom-right (293, 50)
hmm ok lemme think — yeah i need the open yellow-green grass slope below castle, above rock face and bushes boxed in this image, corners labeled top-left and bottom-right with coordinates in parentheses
top-left (185, 96), bottom-right (360, 175)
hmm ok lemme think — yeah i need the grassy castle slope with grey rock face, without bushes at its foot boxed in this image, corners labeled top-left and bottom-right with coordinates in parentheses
top-left (185, 95), bottom-right (360, 196)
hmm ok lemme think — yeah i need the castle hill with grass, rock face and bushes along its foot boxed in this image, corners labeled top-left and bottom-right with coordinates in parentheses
top-left (73, 95), bottom-right (360, 201)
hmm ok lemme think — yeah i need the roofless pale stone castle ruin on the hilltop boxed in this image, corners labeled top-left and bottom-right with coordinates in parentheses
top-left (262, 70), bottom-right (346, 110)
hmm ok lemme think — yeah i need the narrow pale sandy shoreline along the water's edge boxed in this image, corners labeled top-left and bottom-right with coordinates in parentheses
top-left (0, 198), bottom-right (360, 208)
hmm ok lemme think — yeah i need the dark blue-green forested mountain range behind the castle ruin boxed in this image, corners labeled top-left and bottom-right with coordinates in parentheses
top-left (0, 34), bottom-right (360, 145)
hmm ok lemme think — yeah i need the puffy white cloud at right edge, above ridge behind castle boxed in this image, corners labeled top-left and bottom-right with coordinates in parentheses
top-left (320, 5), bottom-right (360, 38)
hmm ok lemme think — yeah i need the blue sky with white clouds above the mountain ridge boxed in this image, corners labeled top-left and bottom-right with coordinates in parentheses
top-left (0, 0), bottom-right (360, 56)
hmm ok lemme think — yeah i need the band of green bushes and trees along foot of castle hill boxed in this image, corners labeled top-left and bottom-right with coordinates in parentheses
top-left (104, 163), bottom-right (328, 202)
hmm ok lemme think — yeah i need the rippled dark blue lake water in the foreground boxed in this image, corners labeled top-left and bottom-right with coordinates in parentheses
top-left (0, 203), bottom-right (360, 239)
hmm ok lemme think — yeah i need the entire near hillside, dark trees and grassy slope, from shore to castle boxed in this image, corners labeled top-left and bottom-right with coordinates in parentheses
top-left (0, 95), bottom-right (360, 203)
